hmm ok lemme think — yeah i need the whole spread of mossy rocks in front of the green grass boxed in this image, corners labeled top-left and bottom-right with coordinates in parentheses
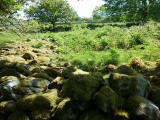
top-left (0, 40), bottom-right (160, 120)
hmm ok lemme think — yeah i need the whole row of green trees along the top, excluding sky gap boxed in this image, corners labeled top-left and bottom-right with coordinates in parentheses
top-left (0, 0), bottom-right (160, 26)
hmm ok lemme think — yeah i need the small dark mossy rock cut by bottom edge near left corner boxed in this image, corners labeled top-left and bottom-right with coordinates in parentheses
top-left (8, 111), bottom-right (29, 120)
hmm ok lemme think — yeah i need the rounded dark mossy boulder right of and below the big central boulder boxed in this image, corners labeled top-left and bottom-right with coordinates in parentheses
top-left (93, 86), bottom-right (123, 113)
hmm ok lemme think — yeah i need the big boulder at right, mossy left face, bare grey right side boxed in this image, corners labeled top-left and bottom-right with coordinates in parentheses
top-left (108, 66), bottom-right (151, 98)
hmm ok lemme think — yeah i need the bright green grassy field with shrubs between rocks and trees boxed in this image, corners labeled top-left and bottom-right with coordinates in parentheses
top-left (0, 22), bottom-right (160, 70)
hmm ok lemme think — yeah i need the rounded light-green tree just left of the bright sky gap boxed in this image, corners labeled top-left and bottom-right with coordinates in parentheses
top-left (26, 0), bottom-right (77, 26)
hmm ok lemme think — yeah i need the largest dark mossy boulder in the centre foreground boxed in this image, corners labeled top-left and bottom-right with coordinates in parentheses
top-left (60, 73), bottom-right (104, 101)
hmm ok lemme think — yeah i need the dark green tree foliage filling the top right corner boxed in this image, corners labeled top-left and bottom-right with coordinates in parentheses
top-left (93, 0), bottom-right (160, 22)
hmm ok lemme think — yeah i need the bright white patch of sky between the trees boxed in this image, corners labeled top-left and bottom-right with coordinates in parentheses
top-left (68, 0), bottom-right (104, 18)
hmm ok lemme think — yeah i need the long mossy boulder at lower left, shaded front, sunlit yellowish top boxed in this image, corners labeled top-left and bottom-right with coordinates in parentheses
top-left (16, 92), bottom-right (61, 112)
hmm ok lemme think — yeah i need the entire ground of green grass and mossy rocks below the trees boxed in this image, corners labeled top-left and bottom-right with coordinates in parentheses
top-left (0, 23), bottom-right (160, 120)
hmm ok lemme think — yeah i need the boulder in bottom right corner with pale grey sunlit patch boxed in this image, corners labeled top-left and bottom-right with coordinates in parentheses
top-left (126, 95), bottom-right (160, 120)
